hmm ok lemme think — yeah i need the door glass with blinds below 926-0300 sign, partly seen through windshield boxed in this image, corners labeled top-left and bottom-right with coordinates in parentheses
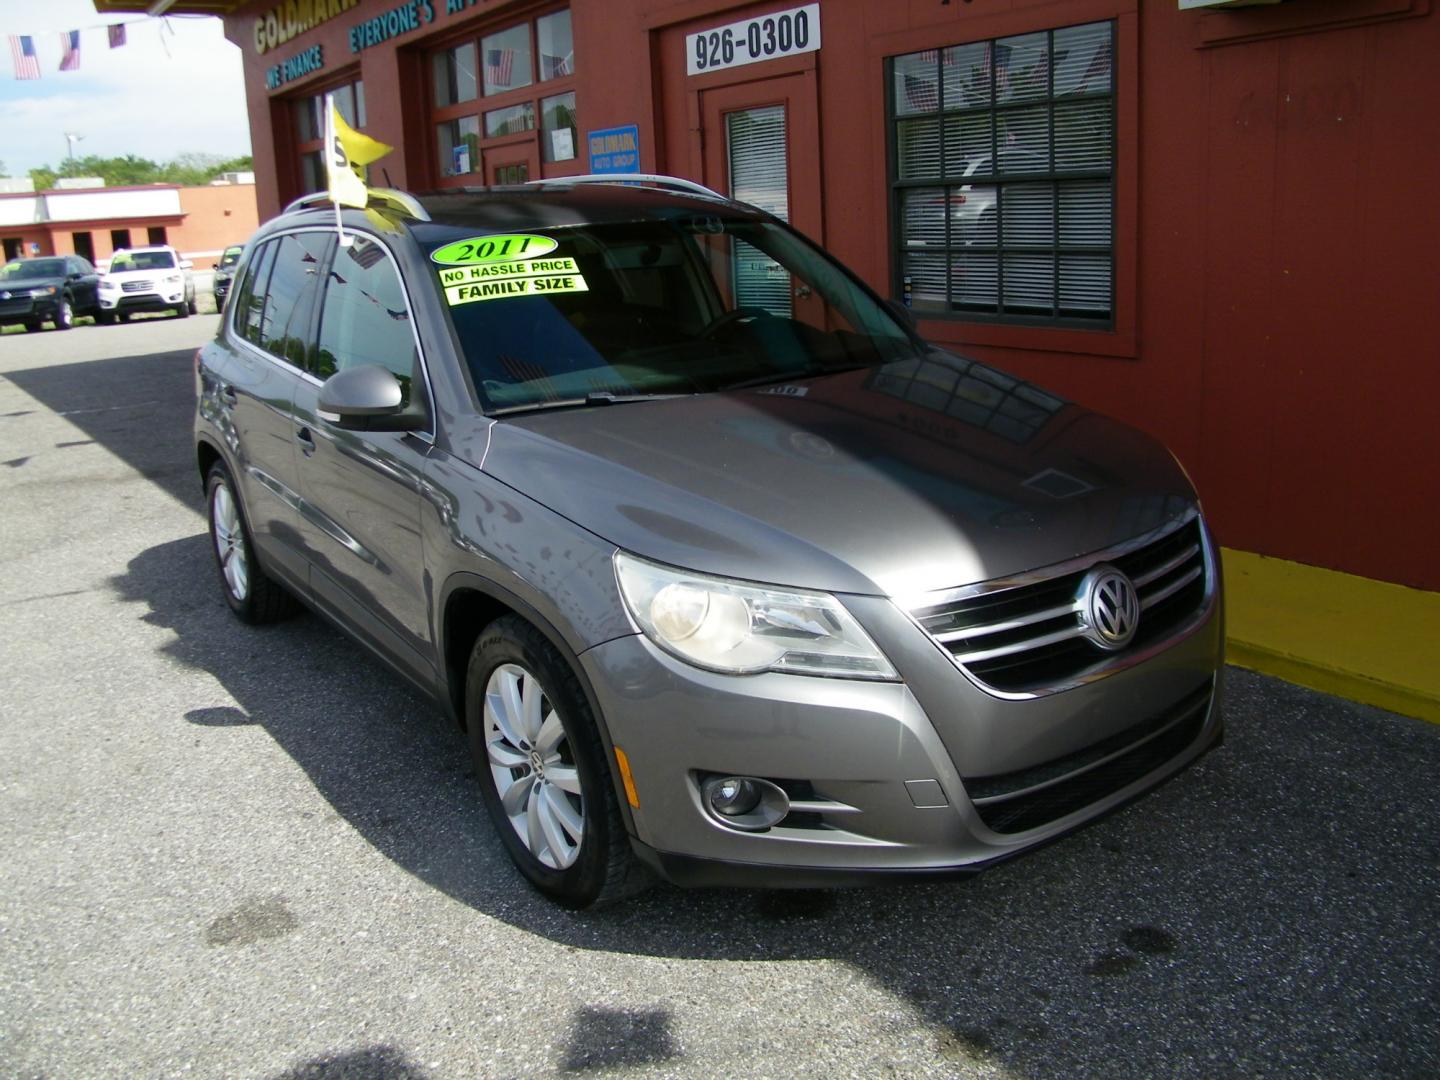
top-left (724, 105), bottom-right (791, 317)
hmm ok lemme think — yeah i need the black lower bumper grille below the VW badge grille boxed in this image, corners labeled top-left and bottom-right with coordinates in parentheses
top-left (965, 680), bottom-right (1214, 832)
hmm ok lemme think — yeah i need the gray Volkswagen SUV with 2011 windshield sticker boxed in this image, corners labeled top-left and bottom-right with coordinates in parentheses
top-left (196, 177), bottom-right (1223, 907)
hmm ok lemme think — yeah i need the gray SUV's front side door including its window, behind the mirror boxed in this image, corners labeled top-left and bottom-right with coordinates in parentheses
top-left (294, 233), bottom-right (435, 680)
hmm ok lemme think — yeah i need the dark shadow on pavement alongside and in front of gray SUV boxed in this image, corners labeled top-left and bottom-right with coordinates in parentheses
top-left (114, 534), bottom-right (1440, 1077)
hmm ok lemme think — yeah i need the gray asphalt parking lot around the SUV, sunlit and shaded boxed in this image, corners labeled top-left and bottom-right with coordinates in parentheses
top-left (0, 315), bottom-right (1440, 1079)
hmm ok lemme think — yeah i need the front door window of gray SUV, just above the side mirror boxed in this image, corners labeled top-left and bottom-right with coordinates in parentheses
top-left (311, 236), bottom-right (418, 402)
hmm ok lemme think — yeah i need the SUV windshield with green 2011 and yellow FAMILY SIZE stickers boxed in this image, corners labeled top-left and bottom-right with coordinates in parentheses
top-left (429, 215), bottom-right (917, 412)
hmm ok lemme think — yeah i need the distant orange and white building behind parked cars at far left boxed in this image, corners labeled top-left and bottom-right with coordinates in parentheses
top-left (0, 173), bottom-right (259, 266)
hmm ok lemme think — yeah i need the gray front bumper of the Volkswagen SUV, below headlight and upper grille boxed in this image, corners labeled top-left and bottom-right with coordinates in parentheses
top-left (580, 598), bottom-right (1223, 887)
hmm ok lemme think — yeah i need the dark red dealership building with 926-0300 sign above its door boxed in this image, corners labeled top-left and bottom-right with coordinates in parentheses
top-left (95, 0), bottom-right (1440, 711)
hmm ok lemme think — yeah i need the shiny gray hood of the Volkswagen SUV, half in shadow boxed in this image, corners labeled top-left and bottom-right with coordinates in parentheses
top-left (484, 351), bottom-right (1194, 596)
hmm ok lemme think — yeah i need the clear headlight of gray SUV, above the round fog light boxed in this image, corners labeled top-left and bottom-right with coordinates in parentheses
top-left (615, 552), bottom-right (899, 680)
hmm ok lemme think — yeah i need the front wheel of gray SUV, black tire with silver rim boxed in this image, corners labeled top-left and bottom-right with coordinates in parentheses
top-left (465, 615), bottom-right (649, 909)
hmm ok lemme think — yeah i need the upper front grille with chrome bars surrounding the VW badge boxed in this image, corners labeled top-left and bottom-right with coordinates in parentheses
top-left (910, 517), bottom-right (1208, 693)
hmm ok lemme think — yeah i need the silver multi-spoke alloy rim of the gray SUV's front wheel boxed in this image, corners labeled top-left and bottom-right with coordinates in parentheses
top-left (484, 664), bottom-right (585, 870)
